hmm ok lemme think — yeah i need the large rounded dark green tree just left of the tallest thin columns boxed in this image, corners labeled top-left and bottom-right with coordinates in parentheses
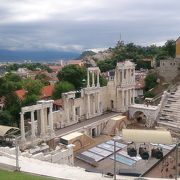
top-left (57, 65), bottom-right (87, 90)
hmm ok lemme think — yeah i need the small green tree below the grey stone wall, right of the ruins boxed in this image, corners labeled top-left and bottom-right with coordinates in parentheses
top-left (145, 71), bottom-right (157, 91)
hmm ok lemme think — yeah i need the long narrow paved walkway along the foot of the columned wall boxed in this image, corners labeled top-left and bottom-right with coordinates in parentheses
top-left (55, 112), bottom-right (120, 137)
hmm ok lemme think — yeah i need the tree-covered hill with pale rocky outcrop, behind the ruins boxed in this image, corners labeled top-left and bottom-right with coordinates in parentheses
top-left (83, 40), bottom-right (176, 72)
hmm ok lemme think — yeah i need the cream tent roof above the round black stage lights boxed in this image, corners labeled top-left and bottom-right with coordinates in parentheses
top-left (122, 129), bottom-right (172, 144)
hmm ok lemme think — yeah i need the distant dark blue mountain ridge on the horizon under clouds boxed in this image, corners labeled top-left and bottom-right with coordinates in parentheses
top-left (0, 49), bottom-right (80, 62)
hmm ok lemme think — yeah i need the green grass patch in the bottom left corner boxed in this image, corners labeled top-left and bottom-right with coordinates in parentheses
top-left (0, 170), bottom-right (54, 180)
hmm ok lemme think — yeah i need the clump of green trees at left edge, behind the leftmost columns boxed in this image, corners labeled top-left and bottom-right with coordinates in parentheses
top-left (0, 73), bottom-right (43, 126)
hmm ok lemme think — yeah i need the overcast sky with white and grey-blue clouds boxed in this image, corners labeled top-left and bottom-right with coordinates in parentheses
top-left (0, 0), bottom-right (180, 51)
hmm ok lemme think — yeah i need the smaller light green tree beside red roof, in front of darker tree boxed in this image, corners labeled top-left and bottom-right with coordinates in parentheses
top-left (52, 81), bottom-right (75, 99)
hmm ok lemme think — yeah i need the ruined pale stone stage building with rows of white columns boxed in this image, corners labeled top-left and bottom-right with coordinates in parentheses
top-left (21, 61), bottom-right (135, 144)
